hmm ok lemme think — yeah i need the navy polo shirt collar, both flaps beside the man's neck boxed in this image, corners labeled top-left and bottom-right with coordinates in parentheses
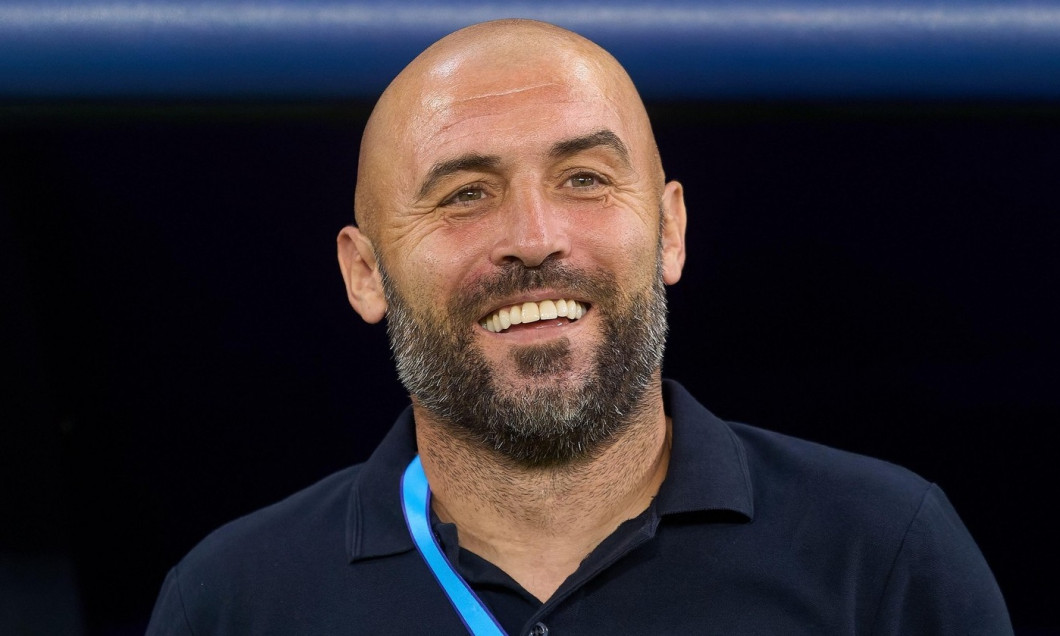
top-left (346, 379), bottom-right (754, 562)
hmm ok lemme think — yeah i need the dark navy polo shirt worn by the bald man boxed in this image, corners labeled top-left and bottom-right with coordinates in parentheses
top-left (147, 382), bottom-right (1012, 636)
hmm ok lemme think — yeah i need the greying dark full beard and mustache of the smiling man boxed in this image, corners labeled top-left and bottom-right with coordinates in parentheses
top-left (376, 254), bottom-right (667, 467)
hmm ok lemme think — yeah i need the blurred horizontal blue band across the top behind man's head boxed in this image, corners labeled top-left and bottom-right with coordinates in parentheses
top-left (0, 0), bottom-right (1060, 101)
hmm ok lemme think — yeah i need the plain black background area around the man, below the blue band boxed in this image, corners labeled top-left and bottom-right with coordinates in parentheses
top-left (0, 101), bottom-right (1060, 635)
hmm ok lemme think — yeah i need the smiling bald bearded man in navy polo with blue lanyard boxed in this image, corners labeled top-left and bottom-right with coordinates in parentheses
top-left (148, 20), bottom-right (1011, 635)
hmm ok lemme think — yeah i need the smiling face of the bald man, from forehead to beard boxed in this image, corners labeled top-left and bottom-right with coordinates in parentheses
top-left (356, 41), bottom-right (682, 465)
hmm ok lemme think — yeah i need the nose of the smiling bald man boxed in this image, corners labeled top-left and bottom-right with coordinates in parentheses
top-left (492, 189), bottom-right (570, 267)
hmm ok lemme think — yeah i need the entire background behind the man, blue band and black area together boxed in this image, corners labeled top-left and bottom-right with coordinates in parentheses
top-left (0, 0), bottom-right (1060, 635)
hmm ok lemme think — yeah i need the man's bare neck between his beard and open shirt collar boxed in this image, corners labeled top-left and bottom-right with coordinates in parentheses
top-left (413, 390), bottom-right (670, 601)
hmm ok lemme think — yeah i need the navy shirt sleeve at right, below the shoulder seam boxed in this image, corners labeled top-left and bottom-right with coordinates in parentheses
top-left (872, 484), bottom-right (1012, 636)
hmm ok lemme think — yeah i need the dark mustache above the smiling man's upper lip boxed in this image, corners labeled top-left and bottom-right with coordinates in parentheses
top-left (451, 260), bottom-right (616, 321)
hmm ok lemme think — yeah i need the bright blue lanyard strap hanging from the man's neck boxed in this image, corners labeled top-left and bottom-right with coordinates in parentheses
top-left (401, 455), bottom-right (507, 636)
